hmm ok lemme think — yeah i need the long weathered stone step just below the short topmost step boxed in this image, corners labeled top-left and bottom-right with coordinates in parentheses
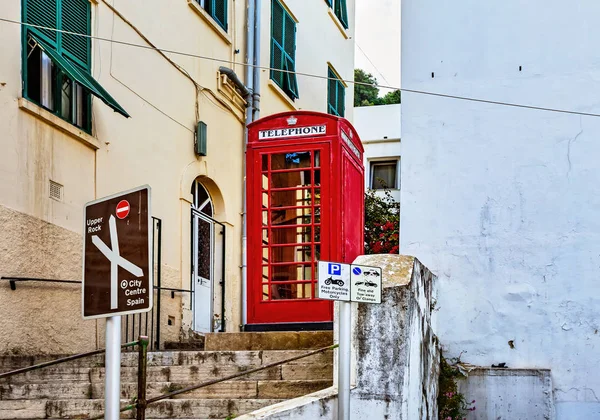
top-left (0, 350), bottom-right (333, 372)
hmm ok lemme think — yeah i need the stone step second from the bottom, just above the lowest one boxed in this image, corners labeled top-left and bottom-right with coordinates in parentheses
top-left (0, 379), bottom-right (333, 400)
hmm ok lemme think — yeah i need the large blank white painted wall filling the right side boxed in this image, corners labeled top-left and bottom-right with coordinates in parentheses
top-left (400, 0), bottom-right (600, 420)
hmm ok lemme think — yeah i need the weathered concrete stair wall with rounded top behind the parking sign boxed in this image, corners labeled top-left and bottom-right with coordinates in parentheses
top-left (239, 255), bottom-right (440, 420)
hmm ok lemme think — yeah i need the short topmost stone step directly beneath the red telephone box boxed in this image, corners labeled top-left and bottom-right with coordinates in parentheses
top-left (204, 331), bottom-right (333, 351)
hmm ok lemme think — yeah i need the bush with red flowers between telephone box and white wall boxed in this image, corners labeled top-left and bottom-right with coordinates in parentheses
top-left (365, 188), bottom-right (400, 254)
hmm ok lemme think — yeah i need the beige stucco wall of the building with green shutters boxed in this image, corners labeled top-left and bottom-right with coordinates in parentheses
top-left (0, 0), bottom-right (354, 353)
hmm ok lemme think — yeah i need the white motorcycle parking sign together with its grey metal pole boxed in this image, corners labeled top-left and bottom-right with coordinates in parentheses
top-left (317, 261), bottom-right (381, 420)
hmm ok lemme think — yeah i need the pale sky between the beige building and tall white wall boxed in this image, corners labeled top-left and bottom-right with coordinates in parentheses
top-left (355, 0), bottom-right (400, 95)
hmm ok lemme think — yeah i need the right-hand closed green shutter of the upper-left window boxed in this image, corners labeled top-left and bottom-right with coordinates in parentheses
top-left (60, 0), bottom-right (91, 70)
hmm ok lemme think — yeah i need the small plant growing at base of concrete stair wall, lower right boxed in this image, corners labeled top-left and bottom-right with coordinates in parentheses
top-left (437, 357), bottom-right (475, 420)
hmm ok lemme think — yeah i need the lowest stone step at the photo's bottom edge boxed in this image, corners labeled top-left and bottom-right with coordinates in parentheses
top-left (0, 399), bottom-right (282, 420)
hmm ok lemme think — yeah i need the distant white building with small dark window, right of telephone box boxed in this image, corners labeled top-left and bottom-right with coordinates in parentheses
top-left (354, 104), bottom-right (402, 202)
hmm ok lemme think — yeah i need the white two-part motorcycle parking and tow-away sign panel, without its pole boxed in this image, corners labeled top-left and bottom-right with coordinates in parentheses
top-left (317, 261), bottom-right (381, 303)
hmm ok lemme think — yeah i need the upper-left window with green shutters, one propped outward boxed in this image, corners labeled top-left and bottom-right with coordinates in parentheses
top-left (23, 0), bottom-right (129, 132)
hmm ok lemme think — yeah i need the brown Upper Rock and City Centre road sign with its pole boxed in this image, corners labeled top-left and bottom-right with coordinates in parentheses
top-left (81, 186), bottom-right (154, 420)
